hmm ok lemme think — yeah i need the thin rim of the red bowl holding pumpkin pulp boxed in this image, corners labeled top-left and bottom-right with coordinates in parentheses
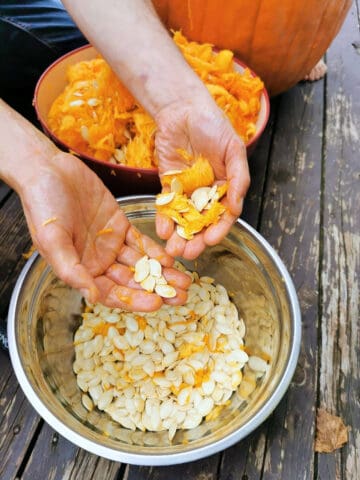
top-left (32, 43), bottom-right (270, 175)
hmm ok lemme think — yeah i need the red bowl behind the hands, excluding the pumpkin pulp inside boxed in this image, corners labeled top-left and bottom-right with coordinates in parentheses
top-left (33, 45), bottom-right (270, 196)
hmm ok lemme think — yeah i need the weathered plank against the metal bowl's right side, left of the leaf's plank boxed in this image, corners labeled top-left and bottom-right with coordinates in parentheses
top-left (220, 74), bottom-right (323, 480)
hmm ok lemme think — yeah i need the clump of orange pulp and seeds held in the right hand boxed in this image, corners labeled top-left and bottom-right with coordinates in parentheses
top-left (155, 155), bottom-right (228, 240)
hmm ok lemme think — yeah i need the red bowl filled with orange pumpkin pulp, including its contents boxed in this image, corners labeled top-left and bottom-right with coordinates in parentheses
top-left (34, 32), bottom-right (269, 196)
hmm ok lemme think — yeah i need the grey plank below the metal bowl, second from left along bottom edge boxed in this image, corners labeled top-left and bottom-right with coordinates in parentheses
top-left (21, 423), bottom-right (121, 480)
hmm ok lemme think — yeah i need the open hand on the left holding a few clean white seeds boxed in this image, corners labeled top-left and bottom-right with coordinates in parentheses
top-left (20, 152), bottom-right (191, 311)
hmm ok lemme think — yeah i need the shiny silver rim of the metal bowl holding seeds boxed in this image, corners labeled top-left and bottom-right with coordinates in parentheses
top-left (7, 195), bottom-right (302, 466)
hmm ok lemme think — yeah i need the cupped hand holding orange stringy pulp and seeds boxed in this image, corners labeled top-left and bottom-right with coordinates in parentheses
top-left (155, 95), bottom-right (250, 259)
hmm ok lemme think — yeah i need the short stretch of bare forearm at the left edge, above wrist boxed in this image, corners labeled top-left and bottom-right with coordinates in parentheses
top-left (0, 99), bottom-right (58, 194)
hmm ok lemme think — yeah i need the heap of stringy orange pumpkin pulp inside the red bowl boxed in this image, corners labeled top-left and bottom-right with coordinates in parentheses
top-left (48, 32), bottom-right (264, 169)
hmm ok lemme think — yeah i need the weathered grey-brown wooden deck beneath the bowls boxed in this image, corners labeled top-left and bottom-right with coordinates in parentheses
top-left (0, 2), bottom-right (360, 480)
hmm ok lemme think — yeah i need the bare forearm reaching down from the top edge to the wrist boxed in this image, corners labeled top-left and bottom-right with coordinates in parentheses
top-left (63, 0), bottom-right (207, 117)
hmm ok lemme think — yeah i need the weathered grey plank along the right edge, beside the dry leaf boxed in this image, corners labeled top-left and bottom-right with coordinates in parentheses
top-left (317, 2), bottom-right (360, 480)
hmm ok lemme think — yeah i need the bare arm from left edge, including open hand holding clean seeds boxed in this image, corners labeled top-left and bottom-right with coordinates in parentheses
top-left (0, 100), bottom-right (189, 311)
